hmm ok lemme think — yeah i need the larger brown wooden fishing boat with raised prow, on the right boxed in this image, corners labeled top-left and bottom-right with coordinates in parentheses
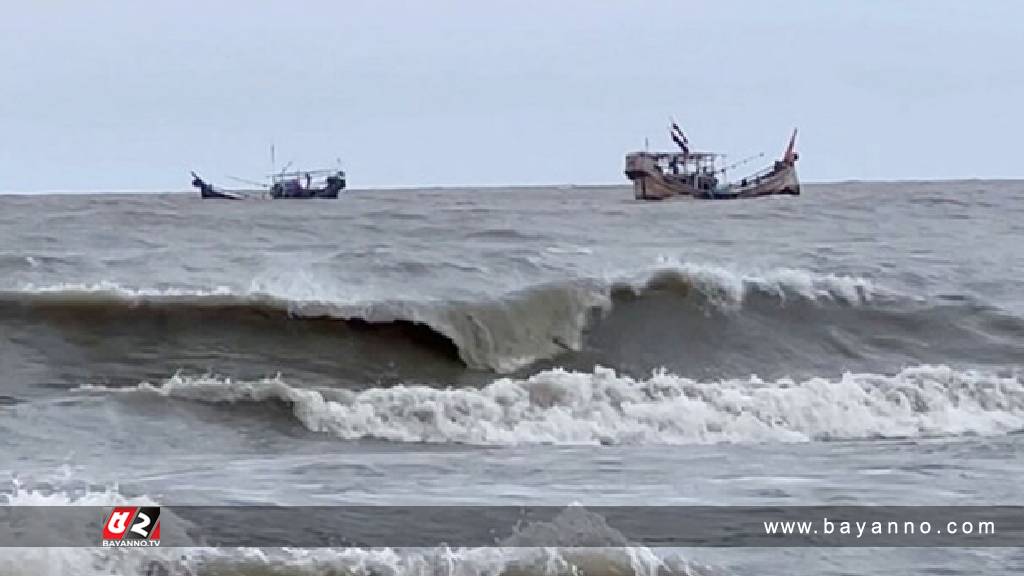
top-left (626, 122), bottom-right (800, 200)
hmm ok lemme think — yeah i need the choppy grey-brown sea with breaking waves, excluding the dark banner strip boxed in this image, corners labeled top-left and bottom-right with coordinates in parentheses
top-left (0, 180), bottom-right (1024, 576)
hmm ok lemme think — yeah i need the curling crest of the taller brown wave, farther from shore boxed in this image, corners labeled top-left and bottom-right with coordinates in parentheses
top-left (0, 263), bottom-right (882, 373)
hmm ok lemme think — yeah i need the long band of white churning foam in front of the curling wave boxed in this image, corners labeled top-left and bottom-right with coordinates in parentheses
top-left (80, 366), bottom-right (1024, 445)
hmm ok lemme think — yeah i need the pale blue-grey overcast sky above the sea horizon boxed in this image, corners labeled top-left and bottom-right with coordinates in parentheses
top-left (0, 0), bottom-right (1024, 191)
